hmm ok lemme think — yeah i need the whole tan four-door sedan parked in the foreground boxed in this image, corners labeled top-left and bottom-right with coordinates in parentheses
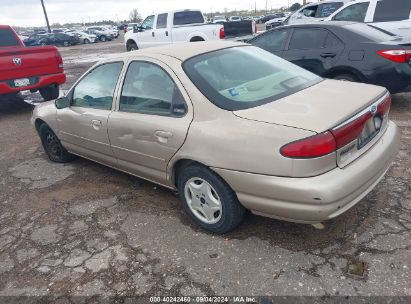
top-left (32, 41), bottom-right (400, 233)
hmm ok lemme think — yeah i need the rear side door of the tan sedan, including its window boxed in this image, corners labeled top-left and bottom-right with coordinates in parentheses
top-left (108, 60), bottom-right (193, 184)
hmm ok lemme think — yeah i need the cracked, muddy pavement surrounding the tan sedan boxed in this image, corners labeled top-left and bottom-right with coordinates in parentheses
top-left (0, 39), bottom-right (411, 296)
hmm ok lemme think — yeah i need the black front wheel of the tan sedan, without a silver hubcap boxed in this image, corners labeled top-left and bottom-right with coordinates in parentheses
top-left (39, 123), bottom-right (76, 163)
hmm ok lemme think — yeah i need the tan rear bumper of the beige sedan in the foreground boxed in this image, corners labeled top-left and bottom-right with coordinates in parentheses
top-left (213, 122), bottom-right (400, 223)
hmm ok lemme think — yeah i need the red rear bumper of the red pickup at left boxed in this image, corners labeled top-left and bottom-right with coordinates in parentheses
top-left (0, 73), bottom-right (66, 94)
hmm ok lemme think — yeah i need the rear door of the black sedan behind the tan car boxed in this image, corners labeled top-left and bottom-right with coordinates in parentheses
top-left (282, 27), bottom-right (344, 76)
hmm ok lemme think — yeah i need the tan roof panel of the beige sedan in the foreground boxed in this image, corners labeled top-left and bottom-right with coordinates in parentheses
top-left (110, 41), bottom-right (248, 61)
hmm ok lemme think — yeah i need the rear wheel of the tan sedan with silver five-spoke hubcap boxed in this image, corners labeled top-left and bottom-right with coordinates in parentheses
top-left (177, 165), bottom-right (246, 234)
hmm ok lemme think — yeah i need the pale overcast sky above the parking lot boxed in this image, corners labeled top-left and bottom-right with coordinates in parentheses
top-left (0, 0), bottom-right (304, 26)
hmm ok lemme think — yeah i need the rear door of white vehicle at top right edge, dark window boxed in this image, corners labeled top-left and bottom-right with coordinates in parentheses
top-left (372, 0), bottom-right (411, 37)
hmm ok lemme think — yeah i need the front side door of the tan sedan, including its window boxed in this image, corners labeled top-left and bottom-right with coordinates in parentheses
top-left (57, 62), bottom-right (123, 165)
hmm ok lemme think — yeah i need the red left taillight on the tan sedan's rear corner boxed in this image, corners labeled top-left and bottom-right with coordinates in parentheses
top-left (280, 131), bottom-right (336, 158)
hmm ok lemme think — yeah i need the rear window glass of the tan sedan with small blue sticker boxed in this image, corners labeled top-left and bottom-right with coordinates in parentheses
top-left (183, 46), bottom-right (322, 111)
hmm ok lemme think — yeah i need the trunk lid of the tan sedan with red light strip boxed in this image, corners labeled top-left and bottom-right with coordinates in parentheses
top-left (234, 80), bottom-right (391, 167)
